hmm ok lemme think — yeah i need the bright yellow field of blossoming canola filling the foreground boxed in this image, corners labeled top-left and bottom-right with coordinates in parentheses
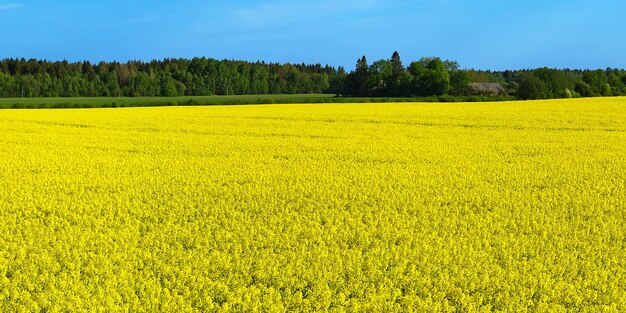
top-left (0, 98), bottom-right (626, 312)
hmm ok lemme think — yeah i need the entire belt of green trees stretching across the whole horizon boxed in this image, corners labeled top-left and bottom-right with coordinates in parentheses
top-left (0, 52), bottom-right (626, 99)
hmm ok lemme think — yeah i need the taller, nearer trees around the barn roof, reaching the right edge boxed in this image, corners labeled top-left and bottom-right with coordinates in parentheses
top-left (333, 52), bottom-right (626, 99)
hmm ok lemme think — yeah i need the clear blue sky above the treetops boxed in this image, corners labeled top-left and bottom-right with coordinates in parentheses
top-left (0, 0), bottom-right (626, 69)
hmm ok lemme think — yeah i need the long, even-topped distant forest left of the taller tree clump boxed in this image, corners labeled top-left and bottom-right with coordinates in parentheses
top-left (0, 58), bottom-right (336, 98)
